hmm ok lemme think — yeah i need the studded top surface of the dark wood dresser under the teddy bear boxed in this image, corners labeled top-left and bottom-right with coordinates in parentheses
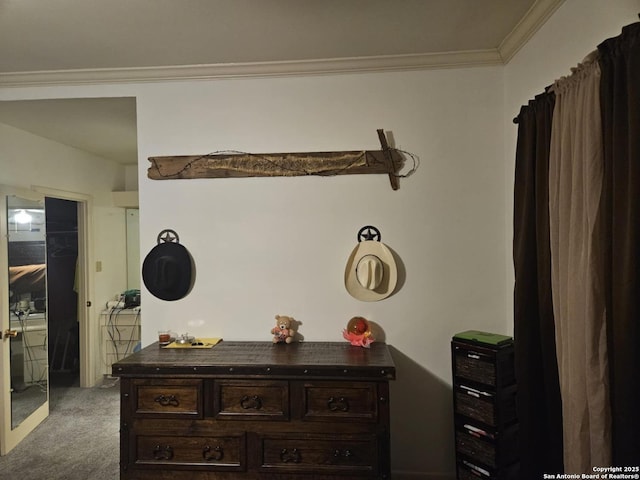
top-left (112, 341), bottom-right (395, 379)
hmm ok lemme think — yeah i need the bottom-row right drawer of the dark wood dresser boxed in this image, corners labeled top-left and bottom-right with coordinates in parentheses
top-left (257, 434), bottom-right (378, 475)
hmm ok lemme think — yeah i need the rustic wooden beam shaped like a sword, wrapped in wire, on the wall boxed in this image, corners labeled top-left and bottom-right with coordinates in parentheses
top-left (147, 130), bottom-right (404, 190)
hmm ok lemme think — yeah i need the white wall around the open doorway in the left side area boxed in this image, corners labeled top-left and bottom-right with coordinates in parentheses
top-left (0, 121), bottom-right (126, 386)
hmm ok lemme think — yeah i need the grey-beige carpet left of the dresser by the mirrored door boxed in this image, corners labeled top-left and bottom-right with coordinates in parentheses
top-left (0, 379), bottom-right (120, 480)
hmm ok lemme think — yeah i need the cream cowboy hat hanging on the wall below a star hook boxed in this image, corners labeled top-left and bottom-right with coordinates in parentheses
top-left (344, 240), bottom-right (398, 302)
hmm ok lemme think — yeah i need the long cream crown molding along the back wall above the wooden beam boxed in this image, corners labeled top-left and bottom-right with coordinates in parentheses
top-left (0, 50), bottom-right (503, 87)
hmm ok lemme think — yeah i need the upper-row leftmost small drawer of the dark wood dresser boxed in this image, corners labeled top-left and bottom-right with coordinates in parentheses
top-left (133, 379), bottom-right (203, 418)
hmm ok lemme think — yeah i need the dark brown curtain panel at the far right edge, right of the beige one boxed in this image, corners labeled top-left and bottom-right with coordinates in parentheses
top-left (598, 23), bottom-right (640, 465)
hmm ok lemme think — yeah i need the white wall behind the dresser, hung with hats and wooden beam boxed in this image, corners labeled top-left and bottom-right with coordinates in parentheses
top-left (137, 68), bottom-right (507, 473)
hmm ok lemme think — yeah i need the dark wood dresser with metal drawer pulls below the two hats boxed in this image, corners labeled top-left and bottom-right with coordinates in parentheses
top-left (112, 341), bottom-right (395, 480)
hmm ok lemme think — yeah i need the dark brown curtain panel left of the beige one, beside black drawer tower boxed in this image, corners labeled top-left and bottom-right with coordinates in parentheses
top-left (513, 93), bottom-right (563, 480)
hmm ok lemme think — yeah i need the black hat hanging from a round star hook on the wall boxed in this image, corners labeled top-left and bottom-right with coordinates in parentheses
top-left (142, 230), bottom-right (195, 301)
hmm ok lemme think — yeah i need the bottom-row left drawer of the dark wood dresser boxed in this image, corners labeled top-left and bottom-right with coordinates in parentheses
top-left (134, 435), bottom-right (246, 471)
